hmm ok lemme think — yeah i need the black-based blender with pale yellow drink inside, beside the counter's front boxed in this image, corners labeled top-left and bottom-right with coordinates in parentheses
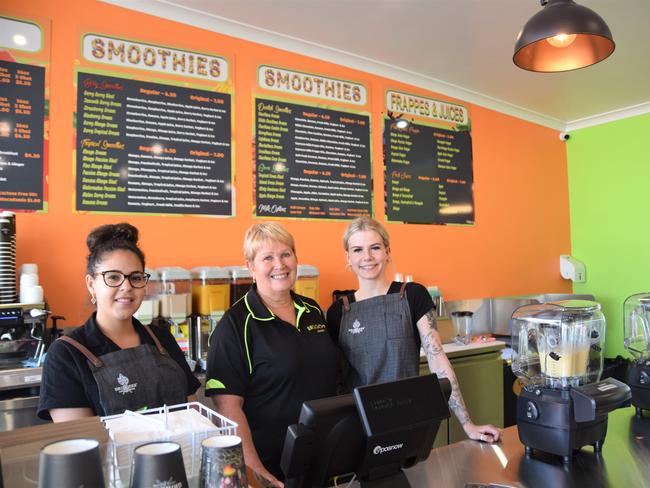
top-left (512, 300), bottom-right (631, 464)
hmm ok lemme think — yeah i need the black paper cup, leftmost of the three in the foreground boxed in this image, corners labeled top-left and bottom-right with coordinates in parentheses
top-left (38, 439), bottom-right (104, 488)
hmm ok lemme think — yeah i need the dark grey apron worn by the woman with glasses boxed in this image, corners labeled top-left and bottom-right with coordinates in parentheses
top-left (58, 324), bottom-right (187, 415)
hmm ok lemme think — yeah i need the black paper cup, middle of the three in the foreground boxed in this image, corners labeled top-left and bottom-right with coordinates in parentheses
top-left (131, 442), bottom-right (188, 488)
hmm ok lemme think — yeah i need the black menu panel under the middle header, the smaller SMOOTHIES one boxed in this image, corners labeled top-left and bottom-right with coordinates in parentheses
top-left (255, 98), bottom-right (372, 219)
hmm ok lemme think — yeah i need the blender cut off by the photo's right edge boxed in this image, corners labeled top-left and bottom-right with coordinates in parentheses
top-left (623, 293), bottom-right (650, 417)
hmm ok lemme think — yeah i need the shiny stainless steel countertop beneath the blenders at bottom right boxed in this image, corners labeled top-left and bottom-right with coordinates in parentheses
top-left (406, 407), bottom-right (650, 488)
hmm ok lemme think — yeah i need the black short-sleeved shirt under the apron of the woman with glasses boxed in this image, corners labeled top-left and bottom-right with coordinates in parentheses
top-left (38, 313), bottom-right (201, 420)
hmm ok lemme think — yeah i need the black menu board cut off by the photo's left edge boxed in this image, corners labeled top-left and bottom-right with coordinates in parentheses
top-left (0, 61), bottom-right (45, 210)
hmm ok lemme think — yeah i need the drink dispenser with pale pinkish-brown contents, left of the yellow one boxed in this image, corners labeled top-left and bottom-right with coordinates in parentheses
top-left (157, 267), bottom-right (192, 362)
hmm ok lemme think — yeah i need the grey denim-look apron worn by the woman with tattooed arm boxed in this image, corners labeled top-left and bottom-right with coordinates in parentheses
top-left (339, 283), bottom-right (420, 391)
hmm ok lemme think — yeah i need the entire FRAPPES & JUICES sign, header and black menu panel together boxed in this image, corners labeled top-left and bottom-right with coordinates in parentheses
top-left (384, 91), bottom-right (474, 224)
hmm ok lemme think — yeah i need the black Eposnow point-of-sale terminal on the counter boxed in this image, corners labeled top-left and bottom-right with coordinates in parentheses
top-left (281, 375), bottom-right (450, 488)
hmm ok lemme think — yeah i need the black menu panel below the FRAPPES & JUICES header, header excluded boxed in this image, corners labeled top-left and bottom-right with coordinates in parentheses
top-left (384, 119), bottom-right (474, 224)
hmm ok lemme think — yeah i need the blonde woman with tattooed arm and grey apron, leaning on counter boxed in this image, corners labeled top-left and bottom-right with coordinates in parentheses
top-left (327, 217), bottom-right (500, 442)
